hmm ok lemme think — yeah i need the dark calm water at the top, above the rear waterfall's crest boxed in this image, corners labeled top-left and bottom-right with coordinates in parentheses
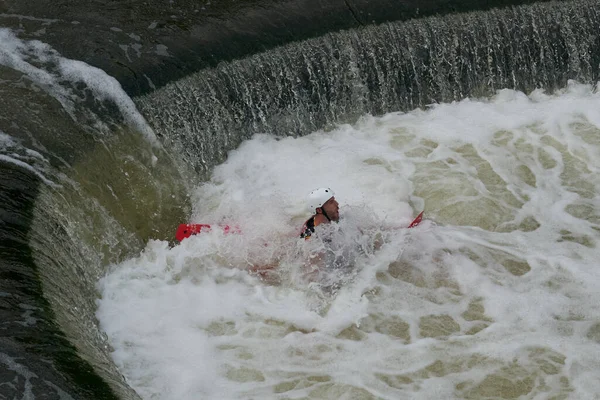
top-left (0, 0), bottom-right (552, 96)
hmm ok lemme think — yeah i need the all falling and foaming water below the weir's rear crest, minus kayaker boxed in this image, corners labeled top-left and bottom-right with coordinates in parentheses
top-left (0, 1), bottom-right (600, 399)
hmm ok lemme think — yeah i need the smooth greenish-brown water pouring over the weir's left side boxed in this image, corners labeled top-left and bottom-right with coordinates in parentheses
top-left (0, 29), bottom-right (186, 399)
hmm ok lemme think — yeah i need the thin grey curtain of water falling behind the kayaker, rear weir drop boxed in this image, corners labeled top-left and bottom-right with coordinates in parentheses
top-left (136, 2), bottom-right (600, 172)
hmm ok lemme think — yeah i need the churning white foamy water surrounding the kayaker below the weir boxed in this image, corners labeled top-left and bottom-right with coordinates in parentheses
top-left (97, 82), bottom-right (600, 399)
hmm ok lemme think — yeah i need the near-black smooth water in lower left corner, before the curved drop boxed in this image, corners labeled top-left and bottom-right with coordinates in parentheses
top-left (0, 162), bottom-right (124, 400)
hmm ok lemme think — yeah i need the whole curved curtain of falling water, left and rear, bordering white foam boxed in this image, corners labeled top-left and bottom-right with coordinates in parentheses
top-left (0, 1), bottom-right (600, 399)
